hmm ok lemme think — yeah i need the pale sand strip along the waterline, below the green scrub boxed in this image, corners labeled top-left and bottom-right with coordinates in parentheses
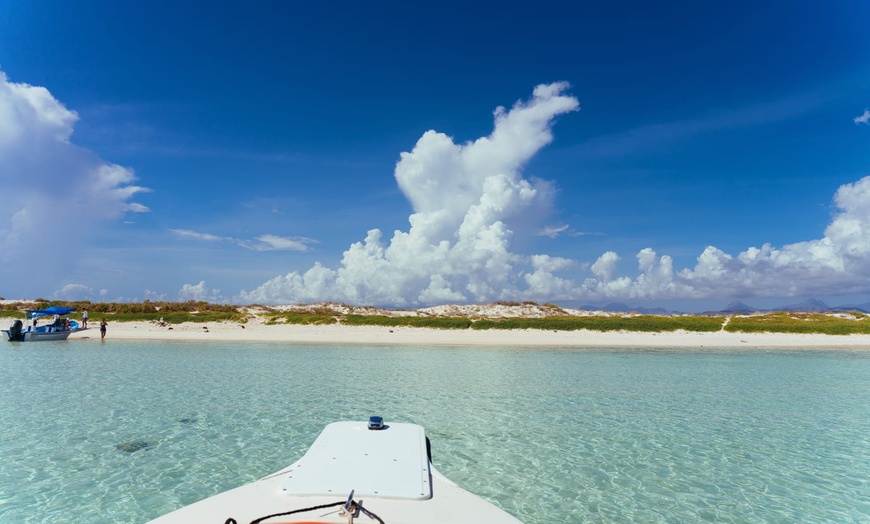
top-left (70, 322), bottom-right (870, 349)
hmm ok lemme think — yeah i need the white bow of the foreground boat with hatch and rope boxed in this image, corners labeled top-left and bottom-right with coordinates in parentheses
top-left (149, 417), bottom-right (522, 524)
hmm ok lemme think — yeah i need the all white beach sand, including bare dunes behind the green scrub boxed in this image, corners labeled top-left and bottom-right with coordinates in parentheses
top-left (6, 300), bottom-right (870, 349)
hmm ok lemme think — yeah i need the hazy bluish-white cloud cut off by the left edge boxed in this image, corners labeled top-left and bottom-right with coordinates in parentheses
top-left (0, 71), bottom-right (147, 290)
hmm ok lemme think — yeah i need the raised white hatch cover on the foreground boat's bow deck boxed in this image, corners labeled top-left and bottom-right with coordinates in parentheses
top-left (282, 422), bottom-right (432, 500)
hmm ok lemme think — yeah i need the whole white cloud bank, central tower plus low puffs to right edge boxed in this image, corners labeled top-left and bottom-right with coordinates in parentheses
top-left (237, 83), bottom-right (870, 306)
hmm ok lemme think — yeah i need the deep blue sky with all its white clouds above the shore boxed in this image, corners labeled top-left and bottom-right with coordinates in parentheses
top-left (0, 0), bottom-right (870, 311)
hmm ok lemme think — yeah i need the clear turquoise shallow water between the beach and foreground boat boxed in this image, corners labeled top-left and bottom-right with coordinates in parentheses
top-left (0, 340), bottom-right (870, 524)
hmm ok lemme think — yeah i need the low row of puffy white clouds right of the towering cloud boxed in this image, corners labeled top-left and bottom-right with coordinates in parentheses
top-left (576, 177), bottom-right (870, 300)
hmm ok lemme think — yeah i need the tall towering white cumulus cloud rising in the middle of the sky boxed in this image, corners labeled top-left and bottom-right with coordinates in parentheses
top-left (239, 83), bottom-right (579, 305)
